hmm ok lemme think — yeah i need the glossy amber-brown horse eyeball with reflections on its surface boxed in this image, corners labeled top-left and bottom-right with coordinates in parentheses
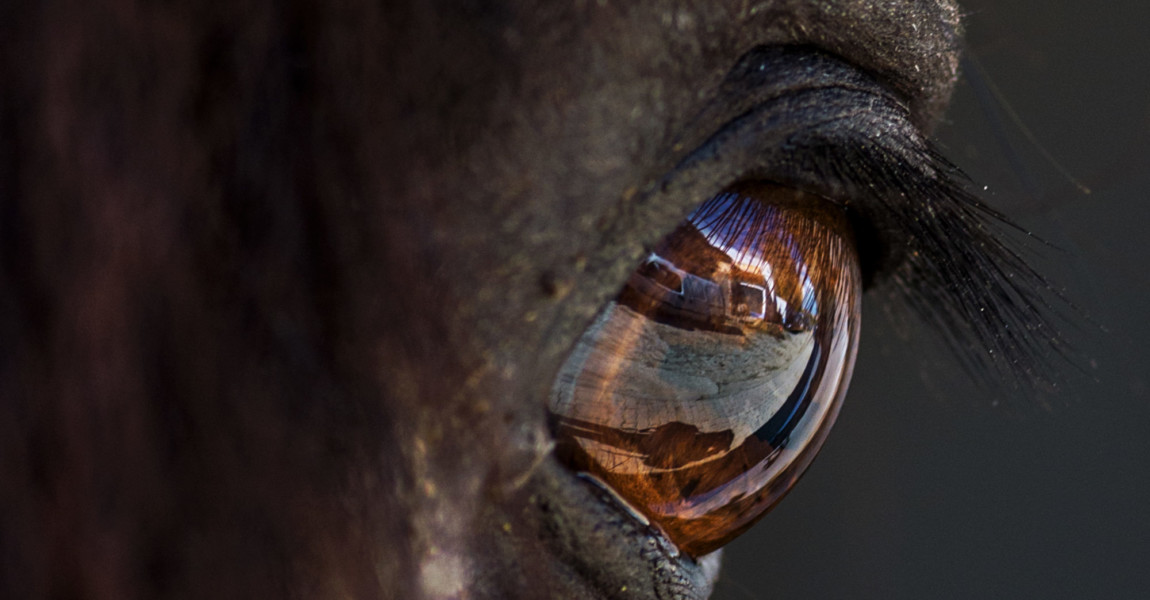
top-left (550, 179), bottom-right (861, 556)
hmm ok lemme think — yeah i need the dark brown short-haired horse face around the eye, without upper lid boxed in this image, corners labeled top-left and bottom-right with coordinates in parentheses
top-left (0, 0), bottom-right (959, 599)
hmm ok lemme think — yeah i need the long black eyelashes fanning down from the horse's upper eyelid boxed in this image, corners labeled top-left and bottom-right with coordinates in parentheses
top-left (791, 134), bottom-right (1075, 403)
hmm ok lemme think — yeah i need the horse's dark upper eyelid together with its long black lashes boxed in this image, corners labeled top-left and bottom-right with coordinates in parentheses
top-left (677, 47), bottom-right (1074, 405)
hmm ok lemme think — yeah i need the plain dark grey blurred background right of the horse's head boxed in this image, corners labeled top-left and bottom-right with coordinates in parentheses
top-left (716, 0), bottom-right (1150, 599)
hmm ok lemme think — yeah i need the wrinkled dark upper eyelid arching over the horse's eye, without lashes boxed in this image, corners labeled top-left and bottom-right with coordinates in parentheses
top-left (597, 46), bottom-right (919, 268)
